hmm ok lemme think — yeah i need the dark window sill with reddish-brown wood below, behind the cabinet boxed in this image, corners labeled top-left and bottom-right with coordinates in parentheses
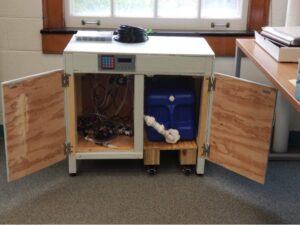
top-left (41, 28), bottom-right (254, 57)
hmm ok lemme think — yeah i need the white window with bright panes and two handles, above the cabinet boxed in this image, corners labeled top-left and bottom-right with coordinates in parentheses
top-left (65, 0), bottom-right (248, 30)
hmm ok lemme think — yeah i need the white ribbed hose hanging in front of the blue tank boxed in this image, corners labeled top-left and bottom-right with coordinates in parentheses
top-left (144, 116), bottom-right (180, 144)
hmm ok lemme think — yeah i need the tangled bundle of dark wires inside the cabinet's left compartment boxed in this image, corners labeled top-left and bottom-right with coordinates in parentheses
top-left (77, 75), bottom-right (133, 143)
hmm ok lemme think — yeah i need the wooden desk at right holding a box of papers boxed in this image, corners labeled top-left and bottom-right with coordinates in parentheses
top-left (235, 39), bottom-right (300, 112)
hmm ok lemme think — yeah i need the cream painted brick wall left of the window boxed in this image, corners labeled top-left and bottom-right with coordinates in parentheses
top-left (0, 0), bottom-right (63, 124)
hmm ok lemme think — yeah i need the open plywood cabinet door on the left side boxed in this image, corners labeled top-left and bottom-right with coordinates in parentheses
top-left (2, 70), bottom-right (65, 181)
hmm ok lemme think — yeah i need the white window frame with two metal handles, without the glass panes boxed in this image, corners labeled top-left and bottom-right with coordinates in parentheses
top-left (64, 0), bottom-right (250, 31)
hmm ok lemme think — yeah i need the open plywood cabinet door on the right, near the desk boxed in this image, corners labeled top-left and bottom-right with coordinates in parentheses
top-left (208, 74), bottom-right (277, 183)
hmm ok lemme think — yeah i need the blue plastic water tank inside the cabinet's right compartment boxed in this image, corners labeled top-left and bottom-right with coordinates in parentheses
top-left (145, 76), bottom-right (196, 141)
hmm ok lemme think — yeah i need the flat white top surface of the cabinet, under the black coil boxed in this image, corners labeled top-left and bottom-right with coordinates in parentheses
top-left (64, 36), bottom-right (215, 57)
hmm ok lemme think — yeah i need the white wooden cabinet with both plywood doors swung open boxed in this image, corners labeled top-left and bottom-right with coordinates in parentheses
top-left (2, 37), bottom-right (276, 183)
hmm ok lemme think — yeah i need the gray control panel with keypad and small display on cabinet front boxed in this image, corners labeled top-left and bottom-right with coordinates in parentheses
top-left (98, 55), bottom-right (136, 72)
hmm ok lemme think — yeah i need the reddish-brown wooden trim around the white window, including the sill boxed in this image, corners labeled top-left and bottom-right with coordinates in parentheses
top-left (41, 0), bottom-right (271, 57)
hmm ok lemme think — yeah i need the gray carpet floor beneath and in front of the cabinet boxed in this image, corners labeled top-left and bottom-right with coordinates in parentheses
top-left (0, 138), bottom-right (300, 224)
